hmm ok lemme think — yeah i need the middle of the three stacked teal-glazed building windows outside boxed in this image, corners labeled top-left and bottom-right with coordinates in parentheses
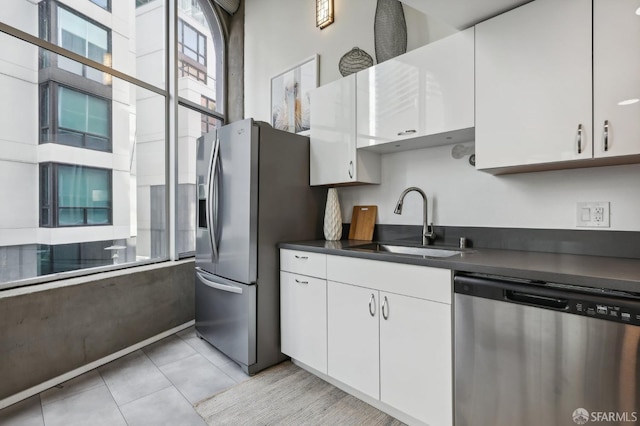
top-left (40, 82), bottom-right (111, 152)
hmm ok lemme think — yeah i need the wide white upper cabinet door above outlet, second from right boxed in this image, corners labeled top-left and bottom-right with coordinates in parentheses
top-left (475, 0), bottom-right (592, 169)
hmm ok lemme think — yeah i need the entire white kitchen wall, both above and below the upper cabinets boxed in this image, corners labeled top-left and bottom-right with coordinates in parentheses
top-left (245, 0), bottom-right (640, 231)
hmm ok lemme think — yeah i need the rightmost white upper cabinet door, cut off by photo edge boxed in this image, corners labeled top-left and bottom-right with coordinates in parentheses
top-left (593, 0), bottom-right (640, 157)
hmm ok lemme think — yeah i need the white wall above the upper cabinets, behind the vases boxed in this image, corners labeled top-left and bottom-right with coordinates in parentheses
top-left (244, 0), bottom-right (455, 122)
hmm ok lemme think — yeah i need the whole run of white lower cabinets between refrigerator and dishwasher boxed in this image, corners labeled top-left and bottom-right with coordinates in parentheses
top-left (280, 250), bottom-right (453, 426)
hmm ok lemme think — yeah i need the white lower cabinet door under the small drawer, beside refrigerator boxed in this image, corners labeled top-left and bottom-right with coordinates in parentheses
top-left (280, 272), bottom-right (327, 374)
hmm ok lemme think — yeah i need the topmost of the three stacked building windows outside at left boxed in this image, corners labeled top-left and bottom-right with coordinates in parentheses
top-left (40, 0), bottom-right (111, 83)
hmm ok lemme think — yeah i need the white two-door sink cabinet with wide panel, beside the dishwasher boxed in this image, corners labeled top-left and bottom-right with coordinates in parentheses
top-left (327, 256), bottom-right (453, 426)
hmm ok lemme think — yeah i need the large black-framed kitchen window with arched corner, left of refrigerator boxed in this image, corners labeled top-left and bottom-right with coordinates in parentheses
top-left (0, 0), bottom-right (225, 290)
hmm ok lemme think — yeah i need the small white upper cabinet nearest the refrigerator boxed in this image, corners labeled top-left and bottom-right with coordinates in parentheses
top-left (310, 74), bottom-right (380, 185)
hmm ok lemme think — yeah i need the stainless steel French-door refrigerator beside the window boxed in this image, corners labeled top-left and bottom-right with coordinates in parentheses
top-left (195, 119), bottom-right (324, 374)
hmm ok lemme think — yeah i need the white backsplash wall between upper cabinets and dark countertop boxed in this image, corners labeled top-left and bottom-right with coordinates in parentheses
top-left (338, 144), bottom-right (640, 231)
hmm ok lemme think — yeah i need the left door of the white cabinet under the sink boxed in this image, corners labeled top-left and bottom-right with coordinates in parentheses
top-left (327, 281), bottom-right (380, 399)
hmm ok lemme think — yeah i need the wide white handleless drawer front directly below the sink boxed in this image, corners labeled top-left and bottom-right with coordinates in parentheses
top-left (327, 256), bottom-right (451, 304)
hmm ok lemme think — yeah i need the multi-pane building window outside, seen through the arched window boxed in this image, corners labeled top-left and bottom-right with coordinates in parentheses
top-left (177, 19), bottom-right (207, 83)
